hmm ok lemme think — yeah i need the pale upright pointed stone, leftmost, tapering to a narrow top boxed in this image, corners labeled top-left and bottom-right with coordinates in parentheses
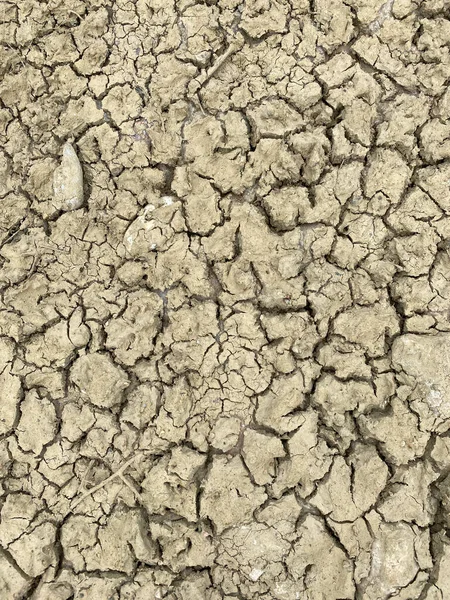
top-left (53, 142), bottom-right (84, 211)
